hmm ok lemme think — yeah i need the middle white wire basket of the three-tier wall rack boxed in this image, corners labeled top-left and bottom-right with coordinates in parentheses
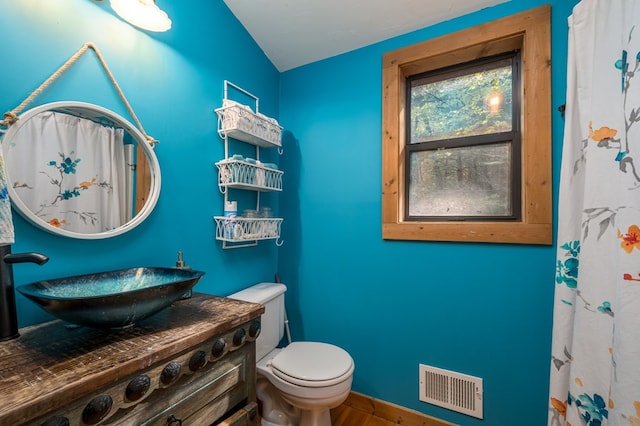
top-left (215, 158), bottom-right (284, 192)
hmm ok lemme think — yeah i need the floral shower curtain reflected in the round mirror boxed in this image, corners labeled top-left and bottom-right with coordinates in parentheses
top-left (9, 111), bottom-right (133, 233)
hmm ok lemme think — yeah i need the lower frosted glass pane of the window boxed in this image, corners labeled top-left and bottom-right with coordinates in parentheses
top-left (409, 143), bottom-right (512, 217)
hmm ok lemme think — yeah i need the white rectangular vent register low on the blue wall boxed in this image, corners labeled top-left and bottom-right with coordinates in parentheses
top-left (420, 364), bottom-right (482, 419)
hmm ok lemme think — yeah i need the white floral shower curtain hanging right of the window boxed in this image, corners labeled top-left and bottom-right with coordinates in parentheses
top-left (548, 0), bottom-right (640, 426)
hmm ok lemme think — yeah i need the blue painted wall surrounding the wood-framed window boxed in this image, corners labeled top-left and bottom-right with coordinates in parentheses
top-left (279, 0), bottom-right (577, 426)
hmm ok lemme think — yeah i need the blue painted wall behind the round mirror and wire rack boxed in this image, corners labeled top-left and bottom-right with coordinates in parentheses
top-left (0, 0), bottom-right (280, 326)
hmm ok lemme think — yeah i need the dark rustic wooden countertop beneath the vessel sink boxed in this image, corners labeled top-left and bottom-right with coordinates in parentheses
top-left (0, 292), bottom-right (264, 425)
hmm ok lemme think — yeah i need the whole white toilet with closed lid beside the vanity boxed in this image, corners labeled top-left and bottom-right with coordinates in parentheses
top-left (229, 283), bottom-right (354, 426)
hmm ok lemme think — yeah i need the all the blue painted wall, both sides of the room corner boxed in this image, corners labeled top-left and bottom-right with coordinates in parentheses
top-left (0, 0), bottom-right (577, 426)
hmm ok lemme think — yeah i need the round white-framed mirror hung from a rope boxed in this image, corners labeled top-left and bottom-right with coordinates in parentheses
top-left (2, 101), bottom-right (160, 239)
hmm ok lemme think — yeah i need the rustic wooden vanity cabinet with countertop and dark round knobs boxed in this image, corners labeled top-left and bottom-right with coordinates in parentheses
top-left (0, 293), bottom-right (264, 426)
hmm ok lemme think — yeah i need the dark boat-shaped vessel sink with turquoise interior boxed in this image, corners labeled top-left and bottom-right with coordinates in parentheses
top-left (17, 268), bottom-right (204, 328)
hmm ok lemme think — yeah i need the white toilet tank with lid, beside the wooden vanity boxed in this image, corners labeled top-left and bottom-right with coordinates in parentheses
top-left (228, 283), bottom-right (287, 360)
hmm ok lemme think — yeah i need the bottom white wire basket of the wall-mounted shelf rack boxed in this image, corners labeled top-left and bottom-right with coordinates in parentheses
top-left (213, 216), bottom-right (282, 248)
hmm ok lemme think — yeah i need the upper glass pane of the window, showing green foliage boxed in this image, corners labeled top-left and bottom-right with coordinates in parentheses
top-left (410, 59), bottom-right (513, 144)
